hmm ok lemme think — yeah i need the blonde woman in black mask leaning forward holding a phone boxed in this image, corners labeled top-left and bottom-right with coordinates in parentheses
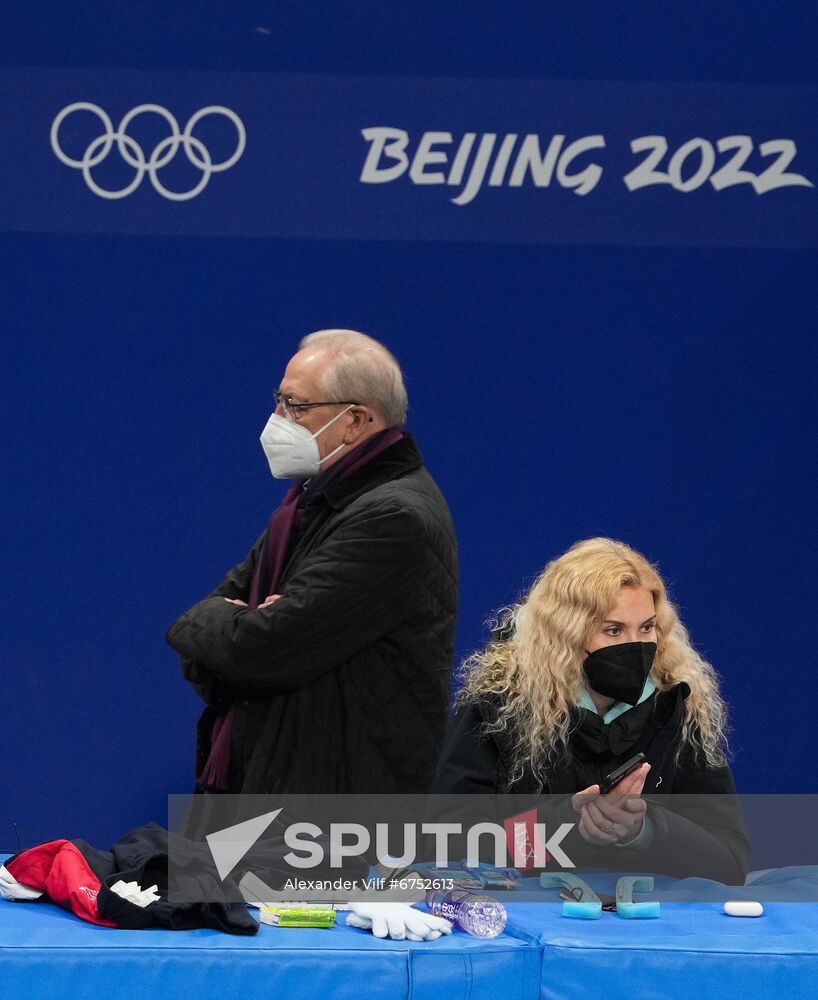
top-left (434, 538), bottom-right (749, 884)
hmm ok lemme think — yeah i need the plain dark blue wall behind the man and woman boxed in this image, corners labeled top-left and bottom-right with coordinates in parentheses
top-left (0, 0), bottom-right (818, 849)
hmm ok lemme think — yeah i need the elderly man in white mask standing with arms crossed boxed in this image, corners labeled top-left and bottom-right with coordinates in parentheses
top-left (167, 330), bottom-right (457, 793)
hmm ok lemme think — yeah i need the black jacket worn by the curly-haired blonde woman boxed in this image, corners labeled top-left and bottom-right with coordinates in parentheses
top-left (432, 684), bottom-right (750, 885)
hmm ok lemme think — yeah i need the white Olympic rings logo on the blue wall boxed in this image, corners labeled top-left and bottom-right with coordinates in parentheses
top-left (51, 101), bottom-right (242, 201)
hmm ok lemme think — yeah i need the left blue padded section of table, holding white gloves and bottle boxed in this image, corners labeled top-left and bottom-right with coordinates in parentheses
top-left (0, 899), bottom-right (542, 1000)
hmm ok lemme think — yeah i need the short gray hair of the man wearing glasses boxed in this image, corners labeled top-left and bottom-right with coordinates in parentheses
top-left (298, 330), bottom-right (408, 427)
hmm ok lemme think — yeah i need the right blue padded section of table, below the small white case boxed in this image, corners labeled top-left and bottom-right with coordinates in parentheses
top-left (510, 902), bottom-right (818, 1000)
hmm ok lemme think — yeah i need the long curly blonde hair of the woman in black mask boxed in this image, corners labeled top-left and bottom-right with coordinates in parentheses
top-left (457, 538), bottom-right (727, 781)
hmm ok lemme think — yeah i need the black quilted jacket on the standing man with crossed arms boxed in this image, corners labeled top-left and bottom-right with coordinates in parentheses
top-left (167, 435), bottom-right (457, 793)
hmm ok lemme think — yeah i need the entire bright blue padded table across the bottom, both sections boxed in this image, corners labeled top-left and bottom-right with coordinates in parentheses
top-left (0, 860), bottom-right (818, 1000)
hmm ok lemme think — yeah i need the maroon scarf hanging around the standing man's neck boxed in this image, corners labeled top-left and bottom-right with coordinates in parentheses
top-left (199, 427), bottom-right (403, 792)
